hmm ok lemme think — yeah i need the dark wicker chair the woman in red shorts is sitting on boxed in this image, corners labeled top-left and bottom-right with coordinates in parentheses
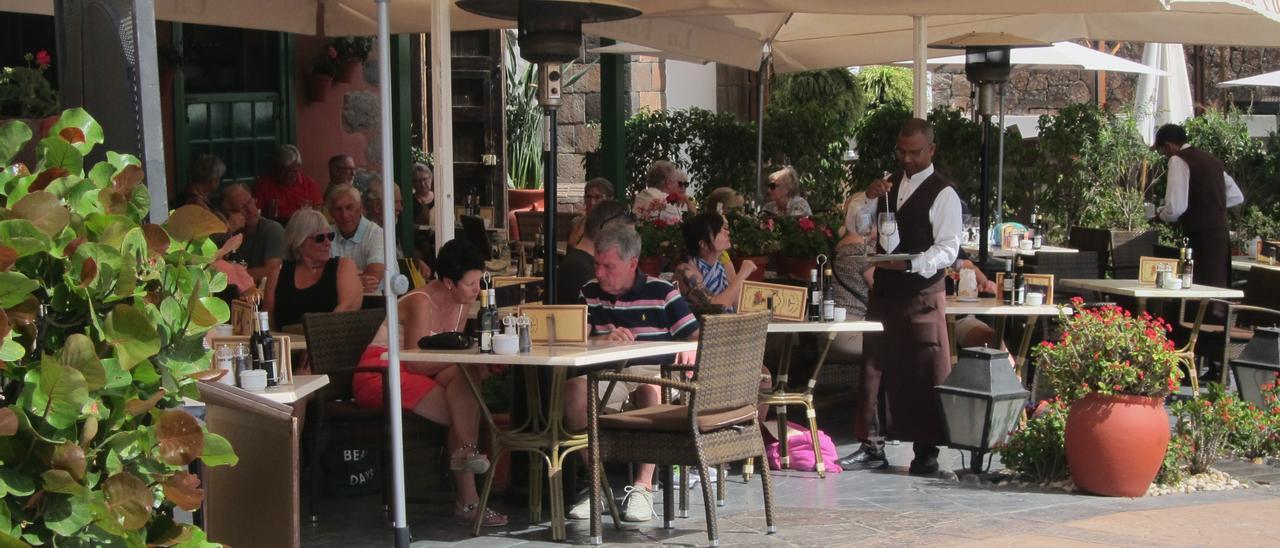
top-left (302, 309), bottom-right (447, 522)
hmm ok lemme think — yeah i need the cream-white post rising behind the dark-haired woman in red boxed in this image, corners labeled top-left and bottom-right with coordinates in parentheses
top-left (430, 0), bottom-right (453, 250)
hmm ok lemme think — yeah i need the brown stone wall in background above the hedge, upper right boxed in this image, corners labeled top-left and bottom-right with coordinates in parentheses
top-left (933, 42), bottom-right (1280, 115)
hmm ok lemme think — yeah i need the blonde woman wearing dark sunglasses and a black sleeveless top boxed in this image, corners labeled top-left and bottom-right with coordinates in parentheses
top-left (265, 209), bottom-right (362, 329)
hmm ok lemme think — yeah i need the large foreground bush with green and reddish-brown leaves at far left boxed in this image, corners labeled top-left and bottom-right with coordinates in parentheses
top-left (0, 109), bottom-right (236, 547)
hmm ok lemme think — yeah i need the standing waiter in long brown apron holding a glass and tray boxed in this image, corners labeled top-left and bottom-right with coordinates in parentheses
top-left (854, 118), bottom-right (961, 475)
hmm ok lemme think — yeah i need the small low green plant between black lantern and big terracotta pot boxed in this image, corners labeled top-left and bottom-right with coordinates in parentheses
top-left (996, 398), bottom-right (1070, 483)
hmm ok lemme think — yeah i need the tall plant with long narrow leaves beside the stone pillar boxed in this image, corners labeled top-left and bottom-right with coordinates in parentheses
top-left (503, 31), bottom-right (590, 189)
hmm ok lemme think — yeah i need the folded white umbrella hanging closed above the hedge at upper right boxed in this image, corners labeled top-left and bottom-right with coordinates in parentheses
top-left (1134, 44), bottom-right (1196, 145)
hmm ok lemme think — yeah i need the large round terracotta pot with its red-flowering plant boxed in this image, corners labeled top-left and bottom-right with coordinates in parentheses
top-left (1034, 297), bottom-right (1183, 497)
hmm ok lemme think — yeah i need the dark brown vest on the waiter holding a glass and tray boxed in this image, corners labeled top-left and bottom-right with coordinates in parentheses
top-left (872, 170), bottom-right (952, 296)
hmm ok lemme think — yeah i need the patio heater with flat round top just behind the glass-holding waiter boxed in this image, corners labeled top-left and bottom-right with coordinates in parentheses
top-left (929, 32), bottom-right (1050, 265)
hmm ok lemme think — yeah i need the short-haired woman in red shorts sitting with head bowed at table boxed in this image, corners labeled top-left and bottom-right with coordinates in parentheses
top-left (352, 239), bottom-right (507, 526)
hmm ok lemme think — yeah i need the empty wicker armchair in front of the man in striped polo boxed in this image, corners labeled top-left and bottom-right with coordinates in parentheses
top-left (588, 312), bottom-right (774, 547)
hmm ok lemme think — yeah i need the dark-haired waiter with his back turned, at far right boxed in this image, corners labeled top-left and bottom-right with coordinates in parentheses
top-left (1151, 124), bottom-right (1244, 287)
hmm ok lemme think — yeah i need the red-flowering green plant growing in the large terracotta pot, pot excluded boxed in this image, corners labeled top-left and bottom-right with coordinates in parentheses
top-left (1033, 297), bottom-right (1183, 403)
